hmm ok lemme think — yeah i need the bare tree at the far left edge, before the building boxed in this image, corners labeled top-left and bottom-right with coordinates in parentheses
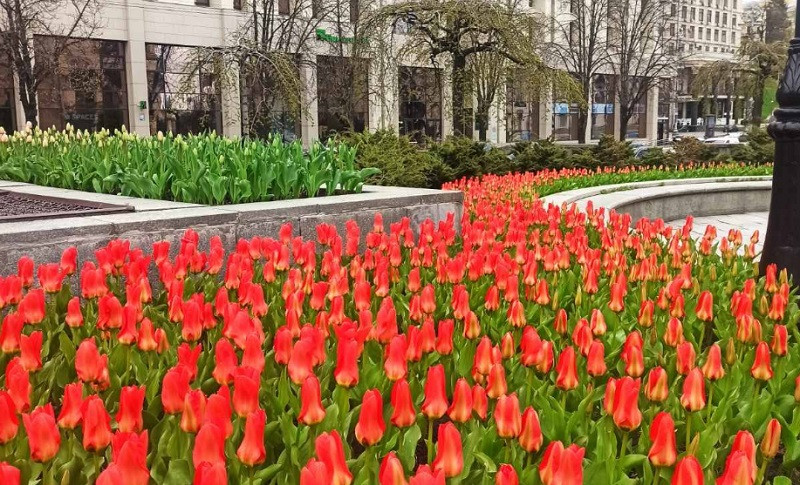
top-left (0, 0), bottom-right (102, 125)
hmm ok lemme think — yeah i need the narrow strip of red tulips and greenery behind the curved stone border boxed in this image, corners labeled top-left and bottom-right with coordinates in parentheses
top-left (442, 162), bottom-right (772, 202)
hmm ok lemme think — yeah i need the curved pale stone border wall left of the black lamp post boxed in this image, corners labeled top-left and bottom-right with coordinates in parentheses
top-left (544, 176), bottom-right (772, 222)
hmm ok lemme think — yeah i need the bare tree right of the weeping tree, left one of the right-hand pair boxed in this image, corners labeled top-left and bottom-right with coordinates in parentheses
top-left (552, 0), bottom-right (609, 143)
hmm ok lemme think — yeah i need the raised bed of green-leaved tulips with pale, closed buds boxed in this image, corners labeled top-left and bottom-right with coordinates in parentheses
top-left (0, 127), bottom-right (378, 205)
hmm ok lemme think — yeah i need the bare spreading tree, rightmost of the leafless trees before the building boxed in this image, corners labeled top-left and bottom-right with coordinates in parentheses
top-left (608, 0), bottom-right (680, 140)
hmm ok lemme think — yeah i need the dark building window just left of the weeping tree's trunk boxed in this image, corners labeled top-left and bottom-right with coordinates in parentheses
top-left (398, 66), bottom-right (442, 142)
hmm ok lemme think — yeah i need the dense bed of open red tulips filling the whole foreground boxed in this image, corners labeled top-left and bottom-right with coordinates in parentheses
top-left (0, 178), bottom-right (800, 485)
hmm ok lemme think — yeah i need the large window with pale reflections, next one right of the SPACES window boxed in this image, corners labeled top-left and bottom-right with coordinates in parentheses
top-left (145, 44), bottom-right (222, 134)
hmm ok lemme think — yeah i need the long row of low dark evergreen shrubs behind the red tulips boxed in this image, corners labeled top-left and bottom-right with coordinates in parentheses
top-left (342, 130), bottom-right (774, 188)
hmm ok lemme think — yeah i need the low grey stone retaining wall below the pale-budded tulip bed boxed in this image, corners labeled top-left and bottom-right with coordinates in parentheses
top-left (0, 181), bottom-right (463, 275)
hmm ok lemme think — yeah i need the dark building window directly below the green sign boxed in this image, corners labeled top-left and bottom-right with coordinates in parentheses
top-left (317, 56), bottom-right (369, 139)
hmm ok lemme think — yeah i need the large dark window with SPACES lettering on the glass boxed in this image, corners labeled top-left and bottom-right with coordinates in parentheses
top-left (34, 36), bottom-right (128, 131)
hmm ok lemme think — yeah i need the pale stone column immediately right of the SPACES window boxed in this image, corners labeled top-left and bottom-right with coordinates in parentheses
top-left (125, 0), bottom-right (150, 136)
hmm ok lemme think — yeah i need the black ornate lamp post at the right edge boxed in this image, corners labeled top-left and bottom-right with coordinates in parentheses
top-left (761, 5), bottom-right (800, 285)
